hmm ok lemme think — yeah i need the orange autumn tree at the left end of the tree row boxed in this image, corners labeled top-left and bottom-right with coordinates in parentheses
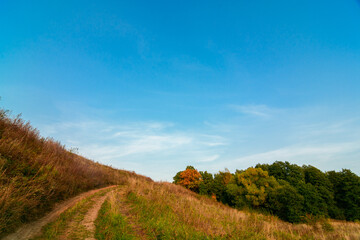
top-left (174, 166), bottom-right (202, 192)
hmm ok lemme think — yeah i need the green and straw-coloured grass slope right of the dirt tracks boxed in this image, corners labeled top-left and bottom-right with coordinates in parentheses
top-left (97, 179), bottom-right (360, 240)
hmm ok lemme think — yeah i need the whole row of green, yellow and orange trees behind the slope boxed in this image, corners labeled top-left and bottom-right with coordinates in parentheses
top-left (174, 161), bottom-right (360, 222)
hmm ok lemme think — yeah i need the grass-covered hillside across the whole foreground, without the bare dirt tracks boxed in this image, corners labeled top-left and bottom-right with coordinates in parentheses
top-left (0, 111), bottom-right (360, 239)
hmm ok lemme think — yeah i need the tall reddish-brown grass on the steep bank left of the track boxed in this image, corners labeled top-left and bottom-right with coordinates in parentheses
top-left (0, 110), bottom-right (149, 237)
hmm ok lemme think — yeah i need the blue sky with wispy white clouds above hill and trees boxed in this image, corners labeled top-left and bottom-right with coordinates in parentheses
top-left (0, 0), bottom-right (360, 181)
